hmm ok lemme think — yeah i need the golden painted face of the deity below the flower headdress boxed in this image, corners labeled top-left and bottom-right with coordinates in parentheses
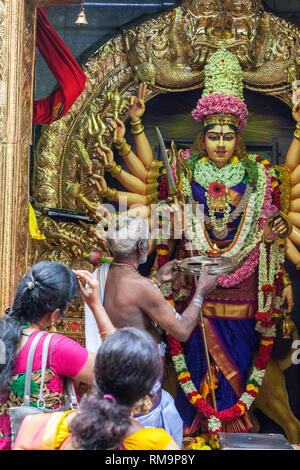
top-left (203, 124), bottom-right (238, 168)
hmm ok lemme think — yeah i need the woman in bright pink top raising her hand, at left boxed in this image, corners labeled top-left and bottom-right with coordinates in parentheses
top-left (0, 261), bottom-right (114, 450)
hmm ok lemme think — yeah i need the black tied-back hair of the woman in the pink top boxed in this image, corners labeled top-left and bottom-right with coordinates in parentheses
top-left (0, 261), bottom-right (79, 393)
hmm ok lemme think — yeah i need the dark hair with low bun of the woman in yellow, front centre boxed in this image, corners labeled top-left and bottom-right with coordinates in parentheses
top-left (71, 328), bottom-right (162, 450)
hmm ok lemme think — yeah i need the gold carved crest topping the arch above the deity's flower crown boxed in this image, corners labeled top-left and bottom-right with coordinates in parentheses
top-left (123, 0), bottom-right (300, 104)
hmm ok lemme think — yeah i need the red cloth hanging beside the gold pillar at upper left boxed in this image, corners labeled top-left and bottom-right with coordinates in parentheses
top-left (33, 8), bottom-right (86, 124)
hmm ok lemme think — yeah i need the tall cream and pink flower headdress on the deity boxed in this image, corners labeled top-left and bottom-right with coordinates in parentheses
top-left (192, 49), bottom-right (248, 131)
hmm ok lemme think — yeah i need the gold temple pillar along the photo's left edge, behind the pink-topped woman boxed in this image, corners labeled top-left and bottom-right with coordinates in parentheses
top-left (0, 0), bottom-right (80, 314)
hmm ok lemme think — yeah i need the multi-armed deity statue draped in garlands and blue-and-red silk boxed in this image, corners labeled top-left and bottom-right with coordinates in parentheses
top-left (94, 49), bottom-right (300, 442)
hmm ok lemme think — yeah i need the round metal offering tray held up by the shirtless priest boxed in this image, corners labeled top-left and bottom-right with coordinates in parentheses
top-left (176, 255), bottom-right (237, 276)
